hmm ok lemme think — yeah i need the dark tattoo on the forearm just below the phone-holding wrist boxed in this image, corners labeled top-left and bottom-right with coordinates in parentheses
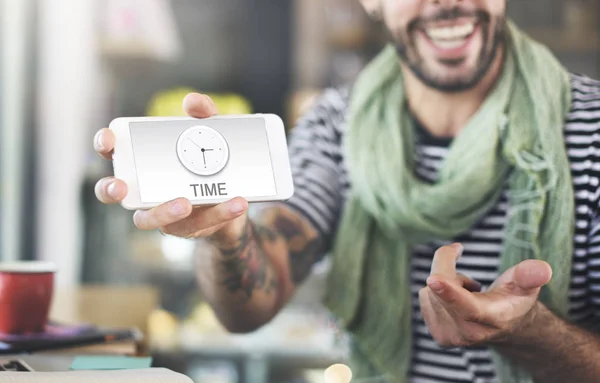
top-left (220, 221), bottom-right (279, 300)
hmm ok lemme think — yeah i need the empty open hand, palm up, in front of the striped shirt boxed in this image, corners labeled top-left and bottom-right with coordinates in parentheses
top-left (419, 244), bottom-right (552, 348)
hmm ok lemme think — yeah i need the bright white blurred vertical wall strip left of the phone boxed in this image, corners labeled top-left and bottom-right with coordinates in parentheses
top-left (37, 0), bottom-right (104, 286)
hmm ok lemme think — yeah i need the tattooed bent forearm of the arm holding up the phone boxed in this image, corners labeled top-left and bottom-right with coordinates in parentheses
top-left (197, 206), bottom-right (323, 332)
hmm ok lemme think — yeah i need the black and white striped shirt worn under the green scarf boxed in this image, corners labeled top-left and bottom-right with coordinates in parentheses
top-left (286, 75), bottom-right (600, 383)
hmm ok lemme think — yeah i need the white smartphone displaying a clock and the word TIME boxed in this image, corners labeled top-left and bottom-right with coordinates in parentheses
top-left (109, 114), bottom-right (294, 210)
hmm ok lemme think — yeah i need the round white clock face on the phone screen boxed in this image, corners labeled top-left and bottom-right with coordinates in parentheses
top-left (177, 126), bottom-right (229, 176)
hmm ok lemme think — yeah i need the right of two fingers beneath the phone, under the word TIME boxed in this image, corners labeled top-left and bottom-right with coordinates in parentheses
top-left (162, 197), bottom-right (248, 237)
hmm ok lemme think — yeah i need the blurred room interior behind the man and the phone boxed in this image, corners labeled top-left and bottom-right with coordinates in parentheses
top-left (0, 0), bottom-right (600, 382)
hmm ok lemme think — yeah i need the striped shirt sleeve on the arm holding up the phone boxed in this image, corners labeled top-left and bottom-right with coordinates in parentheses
top-left (286, 89), bottom-right (347, 244)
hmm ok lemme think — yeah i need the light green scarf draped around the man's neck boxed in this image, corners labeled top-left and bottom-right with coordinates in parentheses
top-left (325, 22), bottom-right (575, 383)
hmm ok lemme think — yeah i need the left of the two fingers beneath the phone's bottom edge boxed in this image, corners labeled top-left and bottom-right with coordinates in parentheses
top-left (133, 198), bottom-right (192, 230)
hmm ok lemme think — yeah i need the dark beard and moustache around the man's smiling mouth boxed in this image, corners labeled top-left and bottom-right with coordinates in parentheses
top-left (394, 7), bottom-right (506, 93)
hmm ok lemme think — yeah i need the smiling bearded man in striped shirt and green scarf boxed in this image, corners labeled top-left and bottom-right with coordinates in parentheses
top-left (96, 0), bottom-right (600, 383)
